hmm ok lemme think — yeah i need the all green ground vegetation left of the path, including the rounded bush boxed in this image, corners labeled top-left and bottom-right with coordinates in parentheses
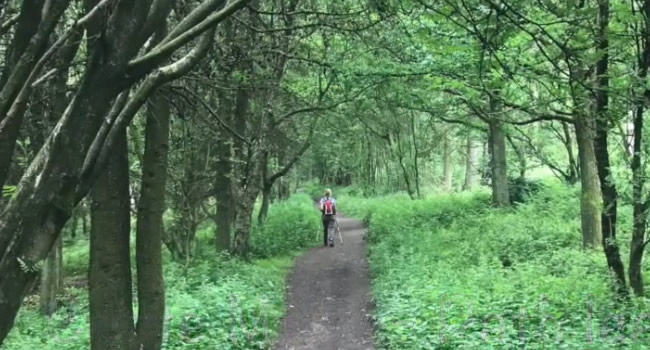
top-left (3, 195), bottom-right (320, 350)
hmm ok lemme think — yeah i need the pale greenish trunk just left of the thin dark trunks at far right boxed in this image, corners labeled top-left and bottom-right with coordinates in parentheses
top-left (575, 117), bottom-right (603, 249)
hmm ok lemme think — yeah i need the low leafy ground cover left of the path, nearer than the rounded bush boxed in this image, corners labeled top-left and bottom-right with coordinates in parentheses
top-left (3, 254), bottom-right (291, 350)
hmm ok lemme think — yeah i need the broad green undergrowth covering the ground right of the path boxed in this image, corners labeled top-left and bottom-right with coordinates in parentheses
top-left (341, 185), bottom-right (650, 350)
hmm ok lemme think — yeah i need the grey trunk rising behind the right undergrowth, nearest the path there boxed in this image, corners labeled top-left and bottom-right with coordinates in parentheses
top-left (489, 119), bottom-right (510, 207)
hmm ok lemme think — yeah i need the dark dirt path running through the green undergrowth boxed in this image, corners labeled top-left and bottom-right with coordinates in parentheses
top-left (275, 217), bottom-right (374, 350)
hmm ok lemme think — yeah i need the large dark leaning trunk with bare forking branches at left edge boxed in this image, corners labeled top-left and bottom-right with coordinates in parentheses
top-left (0, 0), bottom-right (247, 345)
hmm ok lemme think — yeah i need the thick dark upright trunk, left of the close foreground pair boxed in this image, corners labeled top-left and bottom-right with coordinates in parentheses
top-left (88, 131), bottom-right (137, 350)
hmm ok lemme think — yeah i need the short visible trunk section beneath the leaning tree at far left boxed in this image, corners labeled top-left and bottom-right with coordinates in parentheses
top-left (40, 237), bottom-right (63, 316)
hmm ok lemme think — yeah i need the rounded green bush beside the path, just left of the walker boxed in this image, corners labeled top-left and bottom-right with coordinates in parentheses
top-left (251, 194), bottom-right (322, 257)
